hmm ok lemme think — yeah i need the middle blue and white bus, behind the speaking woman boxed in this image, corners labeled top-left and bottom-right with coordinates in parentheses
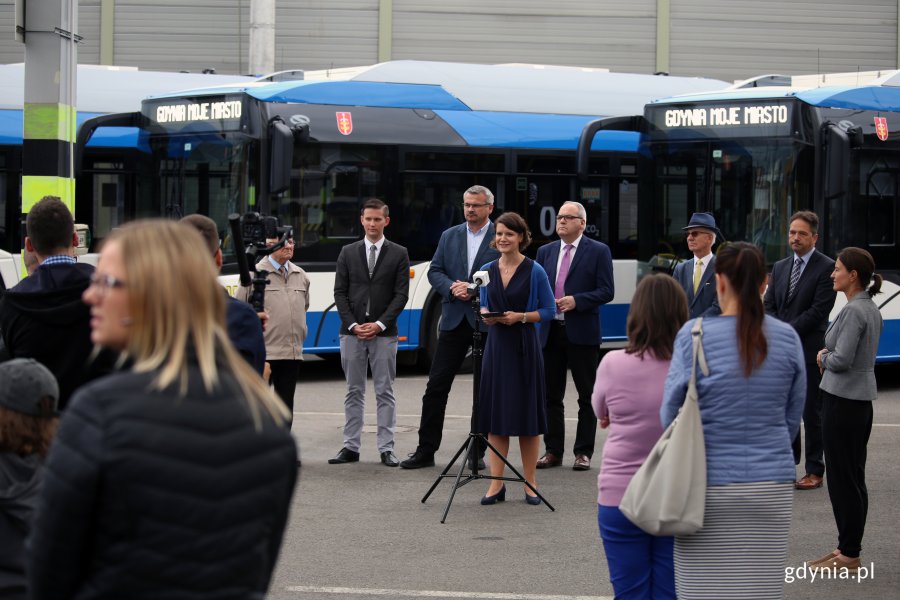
top-left (79, 61), bottom-right (726, 364)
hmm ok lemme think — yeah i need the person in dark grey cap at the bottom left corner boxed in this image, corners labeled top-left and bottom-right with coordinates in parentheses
top-left (0, 358), bottom-right (59, 599)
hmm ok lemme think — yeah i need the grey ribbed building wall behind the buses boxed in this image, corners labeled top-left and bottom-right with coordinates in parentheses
top-left (0, 0), bottom-right (900, 80)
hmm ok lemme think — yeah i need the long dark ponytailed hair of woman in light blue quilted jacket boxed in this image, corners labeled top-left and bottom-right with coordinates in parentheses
top-left (716, 242), bottom-right (769, 377)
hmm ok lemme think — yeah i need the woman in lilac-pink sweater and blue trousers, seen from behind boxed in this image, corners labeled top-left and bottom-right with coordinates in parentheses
top-left (591, 275), bottom-right (688, 600)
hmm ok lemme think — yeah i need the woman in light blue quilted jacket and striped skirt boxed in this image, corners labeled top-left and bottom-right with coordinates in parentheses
top-left (661, 242), bottom-right (806, 600)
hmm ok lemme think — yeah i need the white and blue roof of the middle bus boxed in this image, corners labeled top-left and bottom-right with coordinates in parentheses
top-left (146, 60), bottom-right (729, 117)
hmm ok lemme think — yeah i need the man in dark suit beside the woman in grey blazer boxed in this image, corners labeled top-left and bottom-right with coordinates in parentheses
top-left (765, 210), bottom-right (836, 490)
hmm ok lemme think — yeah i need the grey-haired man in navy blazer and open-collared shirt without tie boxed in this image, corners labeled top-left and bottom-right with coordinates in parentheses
top-left (400, 185), bottom-right (500, 469)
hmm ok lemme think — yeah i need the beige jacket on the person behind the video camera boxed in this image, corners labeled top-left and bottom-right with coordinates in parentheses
top-left (235, 258), bottom-right (309, 360)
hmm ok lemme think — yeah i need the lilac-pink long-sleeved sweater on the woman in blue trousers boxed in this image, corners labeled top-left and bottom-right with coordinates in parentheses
top-left (591, 350), bottom-right (670, 506)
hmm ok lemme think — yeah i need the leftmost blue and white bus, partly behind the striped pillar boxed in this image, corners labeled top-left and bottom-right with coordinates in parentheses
top-left (0, 63), bottom-right (255, 290)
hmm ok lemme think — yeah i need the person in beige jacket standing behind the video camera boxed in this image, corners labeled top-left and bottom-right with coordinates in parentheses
top-left (236, 227), bottom-right (309, 422)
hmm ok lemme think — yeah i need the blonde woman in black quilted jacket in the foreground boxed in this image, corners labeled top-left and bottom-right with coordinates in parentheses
top-left (28, 220), bottom-right (297, 600)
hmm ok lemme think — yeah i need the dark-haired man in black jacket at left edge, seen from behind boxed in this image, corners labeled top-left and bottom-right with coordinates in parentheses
top-left (0, 196), bottom-right (108, 409)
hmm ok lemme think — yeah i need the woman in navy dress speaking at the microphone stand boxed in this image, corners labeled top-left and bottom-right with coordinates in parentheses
top-left (478, 212), bottom-right (556, 504)
